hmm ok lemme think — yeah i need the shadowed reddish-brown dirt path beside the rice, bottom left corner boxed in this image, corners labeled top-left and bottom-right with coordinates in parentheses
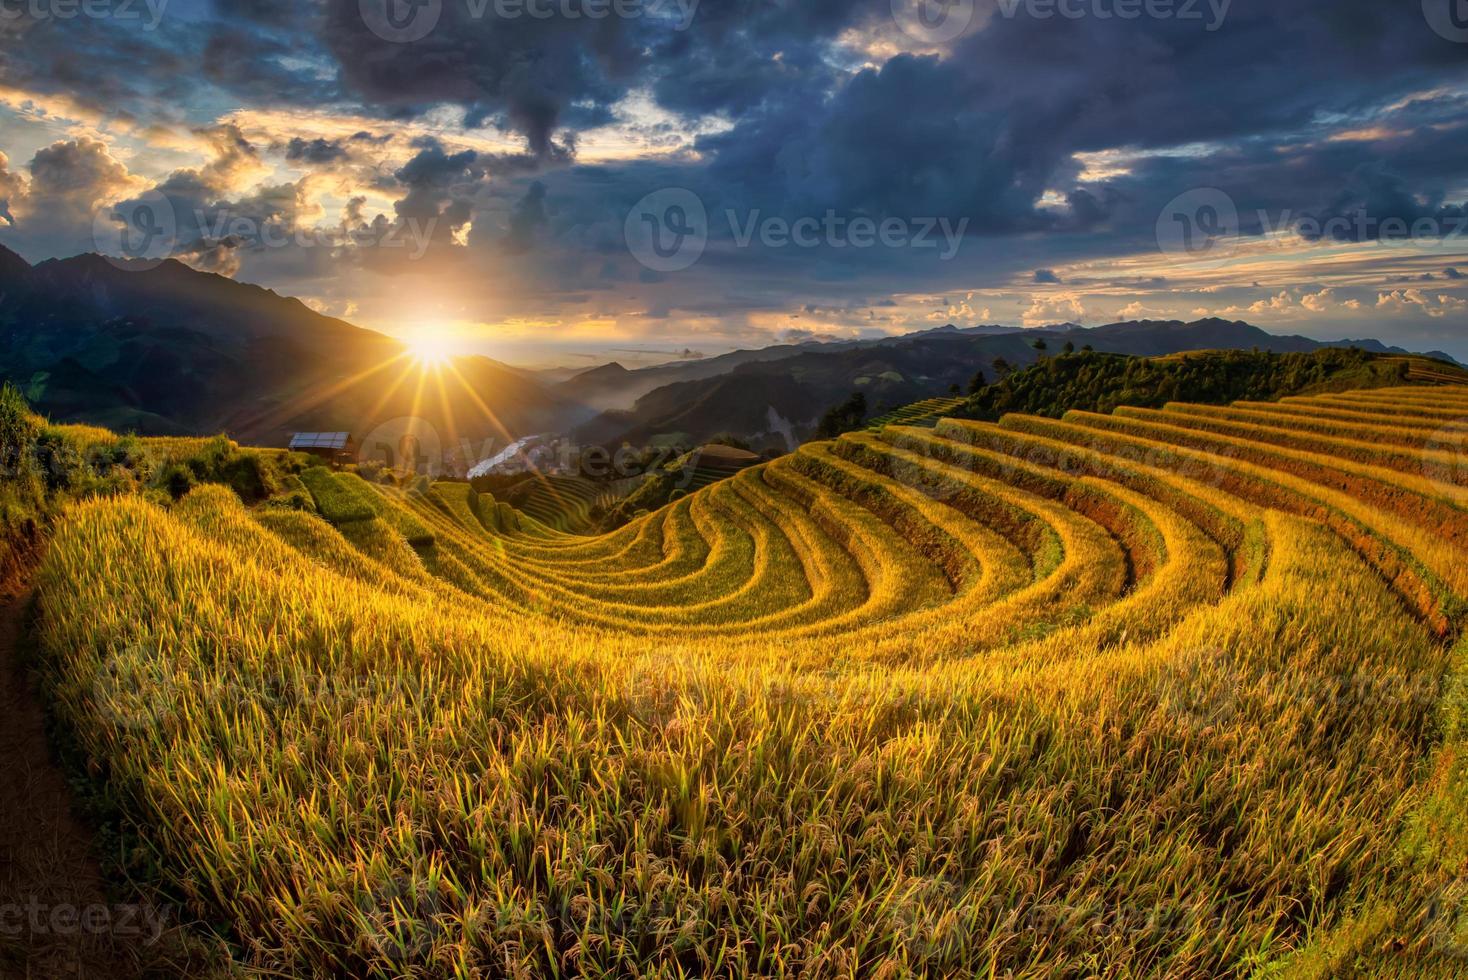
top-left (0, 578), bottom-right (157, 979)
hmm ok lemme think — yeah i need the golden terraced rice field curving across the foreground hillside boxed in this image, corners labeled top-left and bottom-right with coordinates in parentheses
top-left (28, 387), bottom-right (1468, 977)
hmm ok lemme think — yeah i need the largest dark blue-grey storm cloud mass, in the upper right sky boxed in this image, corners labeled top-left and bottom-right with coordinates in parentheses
top-left (678, 0), bottom-right (1468, 244)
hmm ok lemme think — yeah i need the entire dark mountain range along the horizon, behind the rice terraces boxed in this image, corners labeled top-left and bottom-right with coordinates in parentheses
top-left (0, 246), bottom-right (1450, 452)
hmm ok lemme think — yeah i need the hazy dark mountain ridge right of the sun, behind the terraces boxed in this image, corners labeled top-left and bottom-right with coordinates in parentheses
top-left (575, 318), bottom-right (1452, 449)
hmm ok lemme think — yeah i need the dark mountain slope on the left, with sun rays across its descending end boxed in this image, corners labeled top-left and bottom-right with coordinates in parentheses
top-left (0, 246), bottom-right (595, 447)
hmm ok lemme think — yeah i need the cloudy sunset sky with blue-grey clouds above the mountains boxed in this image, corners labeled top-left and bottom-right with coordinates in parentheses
top-left (0, 0), bottom-right (1468, 367)
